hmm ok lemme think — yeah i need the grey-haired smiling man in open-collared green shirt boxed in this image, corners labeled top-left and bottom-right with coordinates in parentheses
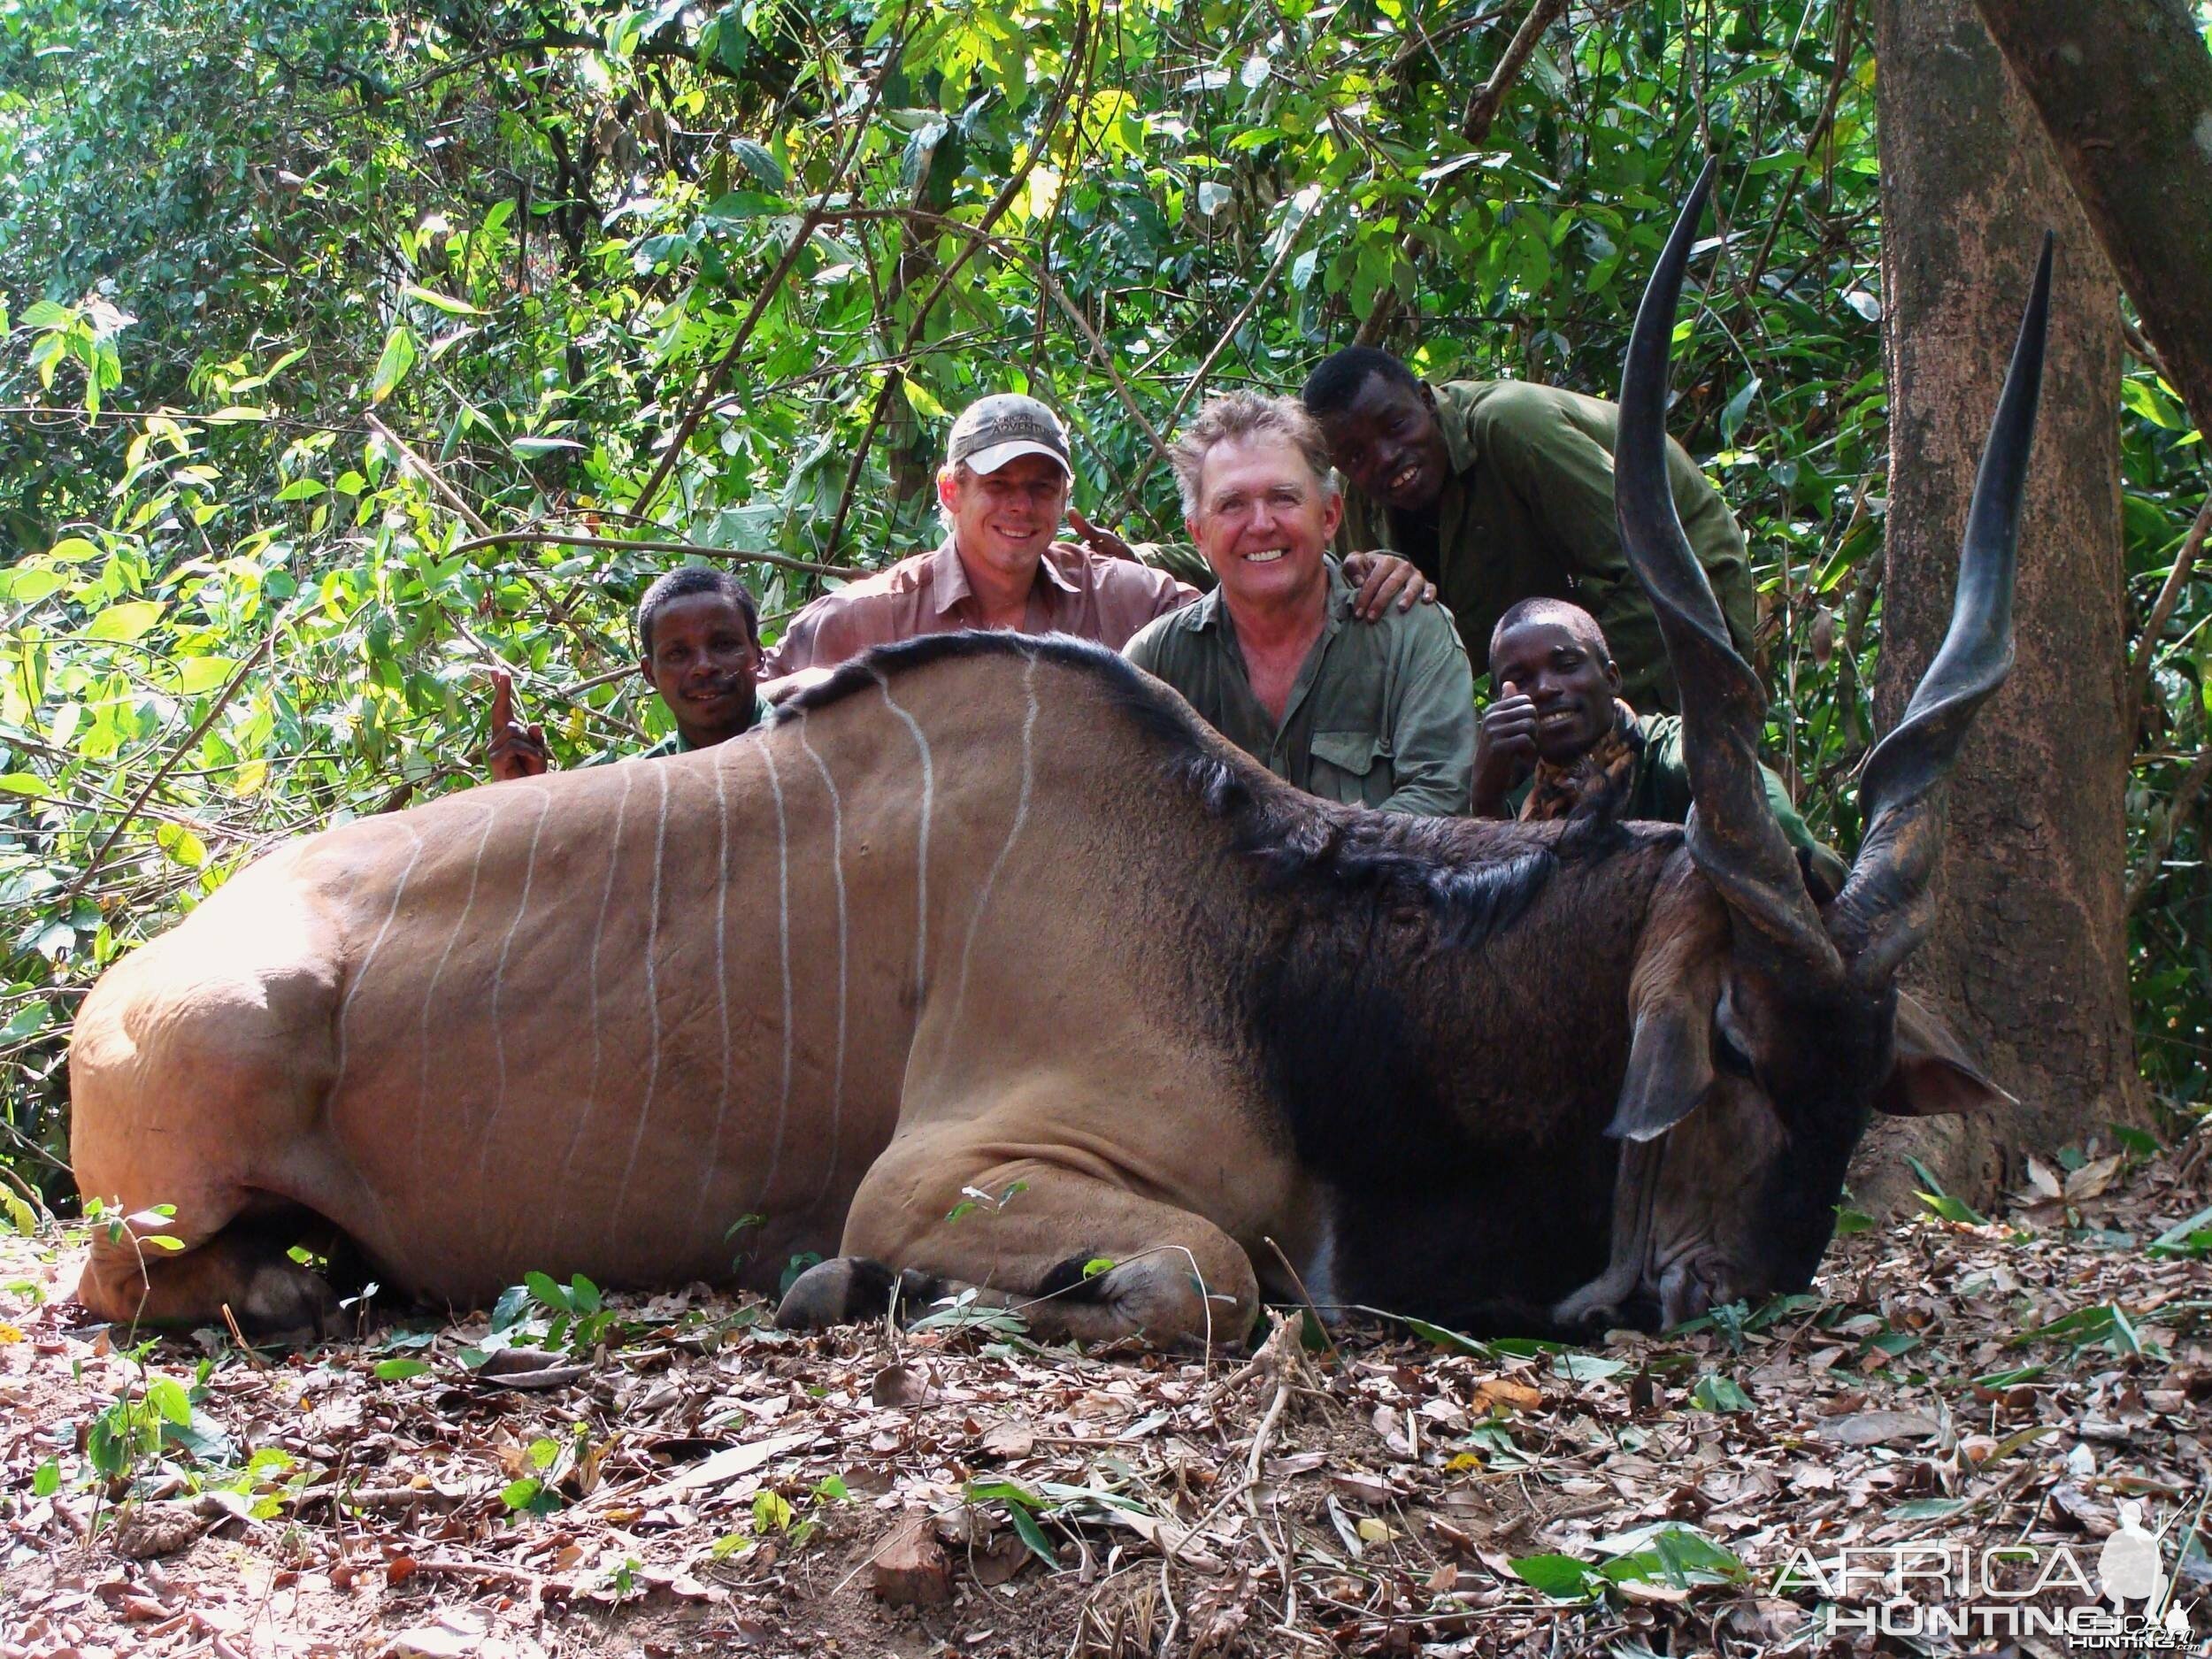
top-left (1124, 392), bottom-right (1476, 817)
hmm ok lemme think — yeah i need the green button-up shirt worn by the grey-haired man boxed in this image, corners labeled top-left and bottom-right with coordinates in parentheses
top-left (1124, 560), bottom-right (1476, 818)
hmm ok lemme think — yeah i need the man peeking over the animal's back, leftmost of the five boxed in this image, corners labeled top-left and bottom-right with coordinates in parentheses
top-left (487, 565), bottom-right (770, 783)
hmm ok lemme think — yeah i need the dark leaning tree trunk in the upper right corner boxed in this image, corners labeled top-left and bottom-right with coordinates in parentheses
top-left (1976, 0), bottom-right (2212, 444)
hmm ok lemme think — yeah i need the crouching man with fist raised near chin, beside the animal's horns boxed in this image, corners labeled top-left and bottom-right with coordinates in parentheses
top-left (1473, 600), bottom-right (1847, 894)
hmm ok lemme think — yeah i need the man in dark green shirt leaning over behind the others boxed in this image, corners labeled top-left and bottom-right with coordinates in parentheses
top-left (1301, 345), bottom-right (1755, 710)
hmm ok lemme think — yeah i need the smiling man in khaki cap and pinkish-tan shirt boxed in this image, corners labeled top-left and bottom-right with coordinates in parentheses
top-left (761, 392), bottom-right (1427, 697)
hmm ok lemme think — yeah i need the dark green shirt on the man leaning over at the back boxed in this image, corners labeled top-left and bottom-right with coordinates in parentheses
top-left (1339, 380), bottom-right (1755, 710)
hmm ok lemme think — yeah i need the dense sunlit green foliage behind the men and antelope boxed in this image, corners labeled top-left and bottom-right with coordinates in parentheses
top-left (0, 0), bottom-right (2212, 1197)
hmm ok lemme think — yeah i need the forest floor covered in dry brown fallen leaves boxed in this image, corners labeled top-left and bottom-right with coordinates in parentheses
top-left (0, 1135), bottom-right (2212, 1659)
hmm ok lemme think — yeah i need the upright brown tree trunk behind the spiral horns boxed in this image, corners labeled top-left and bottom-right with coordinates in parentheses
top-left (1854, 0), bottom-right (2144, 1203)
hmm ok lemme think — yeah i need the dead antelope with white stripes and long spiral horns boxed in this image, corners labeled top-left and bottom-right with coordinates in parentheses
top-left (71, 181), bottom-right (2048, 1340)
